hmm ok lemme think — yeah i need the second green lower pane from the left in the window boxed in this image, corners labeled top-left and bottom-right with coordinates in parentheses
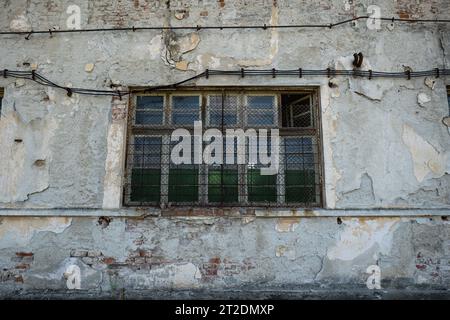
top-left (169, 169), bottom-right (198, 203)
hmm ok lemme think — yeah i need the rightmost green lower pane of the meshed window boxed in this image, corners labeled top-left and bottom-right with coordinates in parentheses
top-left (285, 170), bottom-right (317, 203)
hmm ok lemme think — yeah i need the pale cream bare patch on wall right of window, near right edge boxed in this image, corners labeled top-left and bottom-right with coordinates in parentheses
top-left (402, 124), bottom-right (447, 182)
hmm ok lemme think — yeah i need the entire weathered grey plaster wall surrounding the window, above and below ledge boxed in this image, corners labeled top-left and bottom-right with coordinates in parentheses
top-left (0, 0), bottom-right (450, 296)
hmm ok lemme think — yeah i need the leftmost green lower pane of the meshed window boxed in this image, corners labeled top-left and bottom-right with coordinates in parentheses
top-left (130, 169), bottom-right (161, 202)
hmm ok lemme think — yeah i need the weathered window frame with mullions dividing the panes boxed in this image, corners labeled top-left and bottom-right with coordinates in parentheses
top-left (124, 87), bottom-right (324, 208)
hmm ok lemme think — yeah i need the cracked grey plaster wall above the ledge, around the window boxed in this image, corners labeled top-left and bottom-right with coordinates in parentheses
top-left (0, 0), bottom-right (450, 209)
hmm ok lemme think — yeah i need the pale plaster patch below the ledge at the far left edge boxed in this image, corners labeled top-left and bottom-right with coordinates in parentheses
top-left (0, 217), bottom-right (72, 249)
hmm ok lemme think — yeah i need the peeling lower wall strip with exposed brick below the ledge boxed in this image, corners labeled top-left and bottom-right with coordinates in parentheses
top-left (0, 217), bottom-right (450, 299)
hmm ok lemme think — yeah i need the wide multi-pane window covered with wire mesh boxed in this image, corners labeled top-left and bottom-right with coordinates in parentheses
top-left (124, 89), bottom-right (322, 207)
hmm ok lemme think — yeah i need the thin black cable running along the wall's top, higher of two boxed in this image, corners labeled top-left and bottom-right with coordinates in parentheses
top-left (0, 16), bottom-right (450, 36)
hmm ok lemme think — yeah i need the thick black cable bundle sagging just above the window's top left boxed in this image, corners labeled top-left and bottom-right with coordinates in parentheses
top-left (0, 68), bottom-right (450, 98)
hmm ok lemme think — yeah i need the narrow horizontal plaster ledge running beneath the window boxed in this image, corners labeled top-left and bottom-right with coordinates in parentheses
top-left (0, 208), bottom-right (450, 219)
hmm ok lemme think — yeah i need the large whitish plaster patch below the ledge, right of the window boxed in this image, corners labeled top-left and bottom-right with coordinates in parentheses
top-left (327, 218), bottom-right (400, 261)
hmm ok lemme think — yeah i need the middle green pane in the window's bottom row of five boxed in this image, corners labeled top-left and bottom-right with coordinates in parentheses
top-left (208, 169), bottom-right (239, 203)
